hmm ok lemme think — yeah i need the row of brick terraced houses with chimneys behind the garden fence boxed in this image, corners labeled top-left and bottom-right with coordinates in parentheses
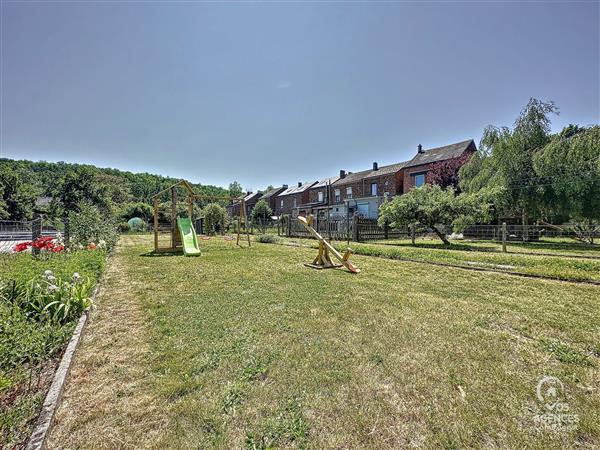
top-left (231, 139), bottom-right (477, 218)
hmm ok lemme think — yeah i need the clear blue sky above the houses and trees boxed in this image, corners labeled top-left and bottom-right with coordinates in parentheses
top-left (0, 0), bottom-right (600, 190)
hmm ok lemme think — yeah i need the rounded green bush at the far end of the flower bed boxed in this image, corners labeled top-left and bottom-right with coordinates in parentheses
top-left (69, 202), bottom-right (118, 250)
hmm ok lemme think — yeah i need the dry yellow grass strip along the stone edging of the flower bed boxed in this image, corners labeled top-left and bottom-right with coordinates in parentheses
top-left (49, 238), bottom-right (165, 449)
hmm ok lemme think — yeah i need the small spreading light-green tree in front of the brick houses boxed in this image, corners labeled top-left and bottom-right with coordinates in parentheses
top-left (379, 184), bottom-right (489, 244)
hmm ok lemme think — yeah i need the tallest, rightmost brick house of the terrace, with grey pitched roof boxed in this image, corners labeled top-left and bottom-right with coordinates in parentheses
top-left (402, 139), bottom-right (477, 192)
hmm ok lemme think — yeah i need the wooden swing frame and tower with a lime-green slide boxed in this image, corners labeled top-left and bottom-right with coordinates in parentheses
top-left (152, 180), bottom-right (250, 255)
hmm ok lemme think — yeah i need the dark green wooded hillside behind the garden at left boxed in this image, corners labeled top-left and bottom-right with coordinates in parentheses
top-left (0, 158), bottom-right (229, 225)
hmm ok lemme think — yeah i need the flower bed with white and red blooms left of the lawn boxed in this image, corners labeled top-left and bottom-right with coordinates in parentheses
top-left (0, 248), bottom-right (106, 448)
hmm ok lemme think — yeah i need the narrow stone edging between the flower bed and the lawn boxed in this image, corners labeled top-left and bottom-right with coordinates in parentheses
top-left (26, 280), bottom-right (100, 450)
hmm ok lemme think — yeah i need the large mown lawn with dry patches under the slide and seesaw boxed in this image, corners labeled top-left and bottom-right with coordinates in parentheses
top-left (50, 236), bottom-right (600, 449)
